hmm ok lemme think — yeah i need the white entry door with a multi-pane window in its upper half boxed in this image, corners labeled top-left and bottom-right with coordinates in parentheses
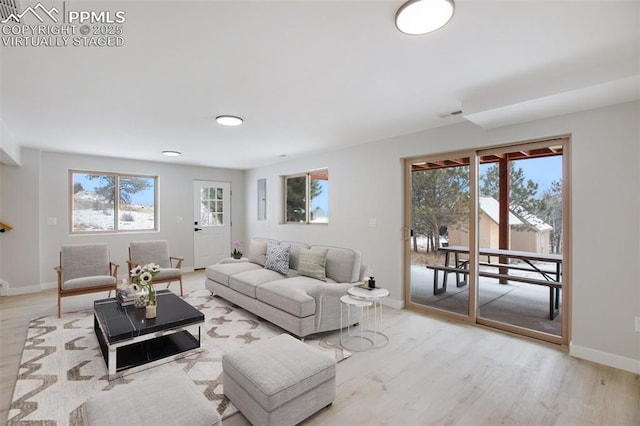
top-left (193, 180), bottom-right (231, 269)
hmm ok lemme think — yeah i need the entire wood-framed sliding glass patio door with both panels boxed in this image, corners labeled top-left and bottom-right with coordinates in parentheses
top-left (405, 136), bottom-right (570, 343)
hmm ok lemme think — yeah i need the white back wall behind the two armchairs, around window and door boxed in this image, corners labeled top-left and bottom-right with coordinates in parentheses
top-left (0, 149), bottom-right (245, 294)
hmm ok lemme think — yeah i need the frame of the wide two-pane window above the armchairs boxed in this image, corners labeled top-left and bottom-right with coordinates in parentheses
top-left (68, 169), bottom-right (160, 235)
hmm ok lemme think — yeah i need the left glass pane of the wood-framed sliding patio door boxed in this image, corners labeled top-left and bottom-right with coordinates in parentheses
top-left (408, 156), bottom-right (470, 316)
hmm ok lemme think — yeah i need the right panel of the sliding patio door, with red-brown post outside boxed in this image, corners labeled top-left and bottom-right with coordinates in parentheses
top-left (477, 141), bottom-right (563, 337)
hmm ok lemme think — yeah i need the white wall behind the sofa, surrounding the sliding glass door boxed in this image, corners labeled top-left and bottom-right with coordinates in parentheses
top-left (246, 102), bottom-right (640, 372)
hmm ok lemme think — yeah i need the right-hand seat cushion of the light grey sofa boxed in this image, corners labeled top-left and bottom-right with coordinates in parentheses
top-left (256, 277), bottom-right (318, 318)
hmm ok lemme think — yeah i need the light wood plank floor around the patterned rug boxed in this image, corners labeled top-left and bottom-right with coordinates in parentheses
top-left (0, 271), bottom-right (640, 426)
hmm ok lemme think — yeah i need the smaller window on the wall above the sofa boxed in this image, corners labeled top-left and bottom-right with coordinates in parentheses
top-left (284, 170), bottom-right (329, 223)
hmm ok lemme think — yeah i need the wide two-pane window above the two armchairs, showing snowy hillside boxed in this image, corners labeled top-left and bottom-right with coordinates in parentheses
top-left (69, 170), bottom-right (158, 233)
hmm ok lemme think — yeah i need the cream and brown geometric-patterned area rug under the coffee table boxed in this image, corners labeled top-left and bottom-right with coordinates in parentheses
top-left (8, 289), bottom-right (351, 426)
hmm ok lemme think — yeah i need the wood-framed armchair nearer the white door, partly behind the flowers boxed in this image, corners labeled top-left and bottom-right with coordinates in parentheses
top-left (127, 240), bottom-right (184, 296)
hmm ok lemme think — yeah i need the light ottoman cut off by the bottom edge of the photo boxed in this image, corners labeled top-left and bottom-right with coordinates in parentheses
top-left (82, 372), bottom-right (222, 426)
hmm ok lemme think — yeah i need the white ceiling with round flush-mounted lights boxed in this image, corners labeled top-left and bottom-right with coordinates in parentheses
top-left (0, 0), bottom-right (640, 169)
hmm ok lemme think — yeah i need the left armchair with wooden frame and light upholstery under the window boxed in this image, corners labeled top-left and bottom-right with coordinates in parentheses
top-left (54, 243), bottom-right (118, 318)
